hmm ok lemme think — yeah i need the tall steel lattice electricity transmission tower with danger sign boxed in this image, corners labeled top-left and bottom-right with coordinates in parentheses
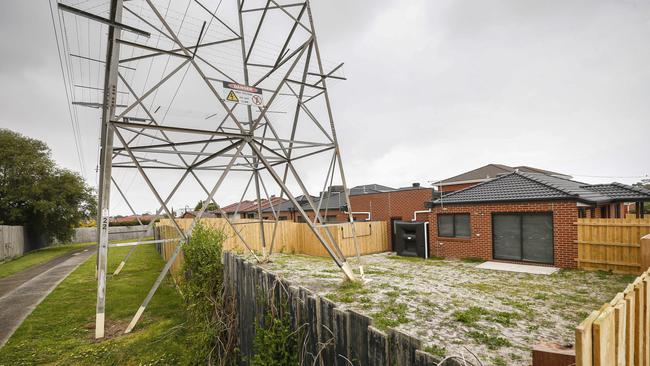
top-left (52, 0), bottom-right (363, 338)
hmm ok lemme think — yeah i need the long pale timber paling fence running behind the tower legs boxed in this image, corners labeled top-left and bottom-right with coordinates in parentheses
top-left (155, 218), bottom-right (390, 272)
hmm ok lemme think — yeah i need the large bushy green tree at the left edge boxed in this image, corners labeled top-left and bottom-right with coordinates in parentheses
top-left (0, 129), bottom-right (97, 241)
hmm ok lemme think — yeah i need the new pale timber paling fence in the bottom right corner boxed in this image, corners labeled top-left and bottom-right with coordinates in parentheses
top-left (575, 258), bottom-right (650, 366)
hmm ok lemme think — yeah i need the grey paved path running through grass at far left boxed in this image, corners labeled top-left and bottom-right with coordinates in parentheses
top-left (0, 246), bottom-right (96, 347)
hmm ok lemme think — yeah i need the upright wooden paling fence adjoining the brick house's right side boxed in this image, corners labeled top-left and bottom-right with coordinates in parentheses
top-left (575, 218), bottom-right (650, 274)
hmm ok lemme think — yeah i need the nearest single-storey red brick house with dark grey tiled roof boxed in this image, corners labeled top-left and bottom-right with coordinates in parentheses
top-left (429, 171), bottom-right (650, 268)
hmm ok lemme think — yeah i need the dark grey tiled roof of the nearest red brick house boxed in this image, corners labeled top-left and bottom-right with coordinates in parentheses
top-left (434, 171), bottom-right (650, 205)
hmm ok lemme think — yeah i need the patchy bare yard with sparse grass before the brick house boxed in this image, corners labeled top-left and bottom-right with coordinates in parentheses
top-left (254, 253), bottom-right (634, 365)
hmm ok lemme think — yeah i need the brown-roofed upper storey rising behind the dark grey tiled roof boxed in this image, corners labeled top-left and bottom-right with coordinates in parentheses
top-left (435, 164), bottom-right (572, 193)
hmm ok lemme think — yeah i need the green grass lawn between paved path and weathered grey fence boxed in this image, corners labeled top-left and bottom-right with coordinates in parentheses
top-left (0, 245), bottom-right (190, 366)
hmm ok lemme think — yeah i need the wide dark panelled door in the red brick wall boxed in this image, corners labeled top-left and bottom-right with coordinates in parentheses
top-left (492, 213), bottom-right (553, 264)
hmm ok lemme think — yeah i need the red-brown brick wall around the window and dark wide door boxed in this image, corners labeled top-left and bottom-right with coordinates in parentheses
top-left (429, 201), bottom-right (578, 268)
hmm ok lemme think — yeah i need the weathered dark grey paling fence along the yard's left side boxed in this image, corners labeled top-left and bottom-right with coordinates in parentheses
top-left (224, 252), bottom-right (457, 366)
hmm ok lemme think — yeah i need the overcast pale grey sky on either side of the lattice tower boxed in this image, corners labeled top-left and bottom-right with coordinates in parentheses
top-left (0, 0), bottom-right (650, 214)
